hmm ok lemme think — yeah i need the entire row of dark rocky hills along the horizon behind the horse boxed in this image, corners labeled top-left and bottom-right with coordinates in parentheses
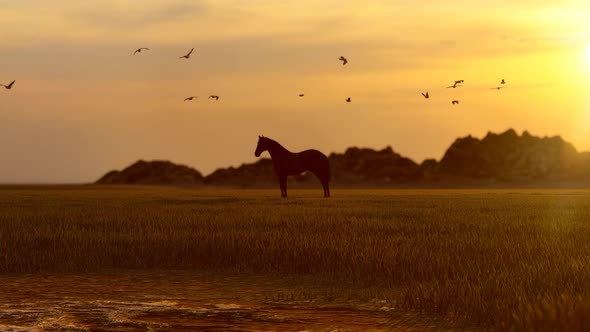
top-left (97, 129), bottom-right (590, 187)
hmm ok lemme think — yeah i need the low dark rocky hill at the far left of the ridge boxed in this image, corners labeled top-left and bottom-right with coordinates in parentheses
top-left (96, 160), bottom-right (203, 185)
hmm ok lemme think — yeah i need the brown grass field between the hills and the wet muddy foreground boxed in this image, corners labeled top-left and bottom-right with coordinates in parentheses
top-left (0, 186), bottom-right (590, 331)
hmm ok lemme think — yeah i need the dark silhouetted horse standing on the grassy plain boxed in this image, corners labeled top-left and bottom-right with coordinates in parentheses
top-left (254, 136), bottom-right (331, 197)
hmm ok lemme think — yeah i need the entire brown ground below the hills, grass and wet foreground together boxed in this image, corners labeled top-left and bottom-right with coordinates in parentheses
top-left (0, 186), bottom-right (590, 331)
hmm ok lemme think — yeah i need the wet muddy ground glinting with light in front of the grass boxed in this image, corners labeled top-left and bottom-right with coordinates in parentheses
top-left (0, 271), bottom-right (468, 331)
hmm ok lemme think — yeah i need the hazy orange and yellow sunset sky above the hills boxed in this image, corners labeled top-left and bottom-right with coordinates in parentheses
top-left (0, 0), bottom-right (590, 183)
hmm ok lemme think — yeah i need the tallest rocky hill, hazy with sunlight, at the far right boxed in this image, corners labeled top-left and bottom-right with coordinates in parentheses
top-left (433, 129), bottom-right (590, 182)
